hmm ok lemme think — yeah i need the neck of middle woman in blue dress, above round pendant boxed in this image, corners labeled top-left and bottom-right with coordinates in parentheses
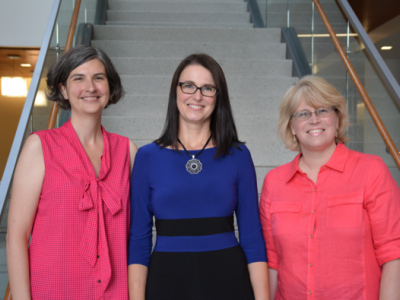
top-left (178, 122), bottom-right (213, 150)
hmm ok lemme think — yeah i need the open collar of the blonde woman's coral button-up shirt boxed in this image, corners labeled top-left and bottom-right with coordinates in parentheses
top-left (286, 143), bottom-right (350, 182)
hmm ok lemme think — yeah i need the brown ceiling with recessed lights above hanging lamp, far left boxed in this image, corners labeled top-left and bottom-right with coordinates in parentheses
top-left (0, 48), bottom-right (40, 77)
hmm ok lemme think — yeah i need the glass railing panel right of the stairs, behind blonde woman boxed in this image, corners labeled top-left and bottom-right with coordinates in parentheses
top-left (258, 0), bottom-right (400, 185)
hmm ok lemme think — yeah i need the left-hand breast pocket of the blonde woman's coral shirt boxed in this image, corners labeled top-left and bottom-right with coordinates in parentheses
top-left (271, 201), bottom-right (303, 235)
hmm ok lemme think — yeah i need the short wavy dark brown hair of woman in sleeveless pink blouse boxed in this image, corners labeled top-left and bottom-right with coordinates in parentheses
top-left (46, 45), bottom-right (125, 110)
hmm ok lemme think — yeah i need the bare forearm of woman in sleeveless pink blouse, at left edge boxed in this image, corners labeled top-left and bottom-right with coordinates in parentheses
top-left (7, 234), bottom-right (31, 300)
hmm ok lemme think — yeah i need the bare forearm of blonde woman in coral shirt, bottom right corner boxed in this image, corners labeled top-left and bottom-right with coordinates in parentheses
top-left (379, 259), bottom-right (400, 300)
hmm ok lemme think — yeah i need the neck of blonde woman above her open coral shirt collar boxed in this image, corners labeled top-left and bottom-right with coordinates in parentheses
top-left (299, 143), bottom-right (336, 171)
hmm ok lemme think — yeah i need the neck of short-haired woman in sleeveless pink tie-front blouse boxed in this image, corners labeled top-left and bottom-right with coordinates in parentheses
top-left (71, 113), bottom-right (103, 144)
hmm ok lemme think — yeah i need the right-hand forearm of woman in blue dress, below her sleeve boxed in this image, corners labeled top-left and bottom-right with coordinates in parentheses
top-left (248, 262), bottom-right (269, 300)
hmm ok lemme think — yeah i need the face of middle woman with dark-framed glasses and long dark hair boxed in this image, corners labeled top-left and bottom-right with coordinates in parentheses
top-left (176, 65), bottom-right (217, 124)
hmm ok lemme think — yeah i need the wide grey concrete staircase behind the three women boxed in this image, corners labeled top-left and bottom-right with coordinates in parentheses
top-left (92, 0), bottom-right (297, 195)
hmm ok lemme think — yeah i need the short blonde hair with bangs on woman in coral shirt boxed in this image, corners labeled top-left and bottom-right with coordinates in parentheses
top-left (278, 75), bottom-right (349, 152)
